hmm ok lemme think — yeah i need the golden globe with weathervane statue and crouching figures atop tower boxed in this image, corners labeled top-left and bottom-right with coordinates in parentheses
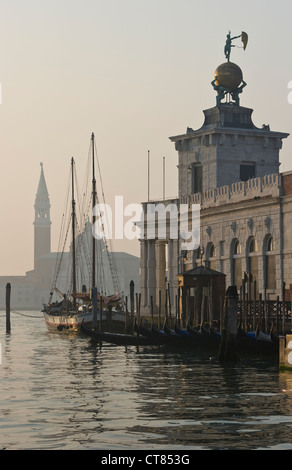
top-left (211, 31), bottom-right (248, 106)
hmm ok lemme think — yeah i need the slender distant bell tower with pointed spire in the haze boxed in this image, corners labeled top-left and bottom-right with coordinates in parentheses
top-left (34, 163), bottom-right (52, 267)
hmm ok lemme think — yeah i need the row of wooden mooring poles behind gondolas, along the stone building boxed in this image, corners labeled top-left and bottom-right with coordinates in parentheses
top-left (126, 280), bottom-right (292, 335)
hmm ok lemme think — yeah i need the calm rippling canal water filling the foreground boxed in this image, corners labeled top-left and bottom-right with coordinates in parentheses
top-left (0, 312), bottom-right (292, 450)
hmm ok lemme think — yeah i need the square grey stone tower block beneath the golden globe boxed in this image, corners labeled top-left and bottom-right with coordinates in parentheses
top-left (170, 104), bottom-right (288, 197)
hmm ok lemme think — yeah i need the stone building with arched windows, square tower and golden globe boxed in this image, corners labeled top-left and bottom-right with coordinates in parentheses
top-left (140, 33), bottom-right (292, 320)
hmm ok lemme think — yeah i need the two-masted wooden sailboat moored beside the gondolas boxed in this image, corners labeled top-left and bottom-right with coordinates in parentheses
top-left (42, 133), bottom-right (125, 332)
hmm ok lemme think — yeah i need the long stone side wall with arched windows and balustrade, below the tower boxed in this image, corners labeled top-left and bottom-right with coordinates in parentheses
top-left (185, 174), bottom-right (283, 297)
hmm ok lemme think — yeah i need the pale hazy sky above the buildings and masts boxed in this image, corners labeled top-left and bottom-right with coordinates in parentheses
top-left (0, 0), bottom-right (292, 275)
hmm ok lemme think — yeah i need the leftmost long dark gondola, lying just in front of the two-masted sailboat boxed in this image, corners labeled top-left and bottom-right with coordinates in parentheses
top-left (80, 322), bottom-right (163, 346)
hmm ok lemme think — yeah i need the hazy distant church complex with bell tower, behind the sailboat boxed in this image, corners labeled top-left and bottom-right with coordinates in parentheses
top-left (0, 163), bottom-right (140, 310)
